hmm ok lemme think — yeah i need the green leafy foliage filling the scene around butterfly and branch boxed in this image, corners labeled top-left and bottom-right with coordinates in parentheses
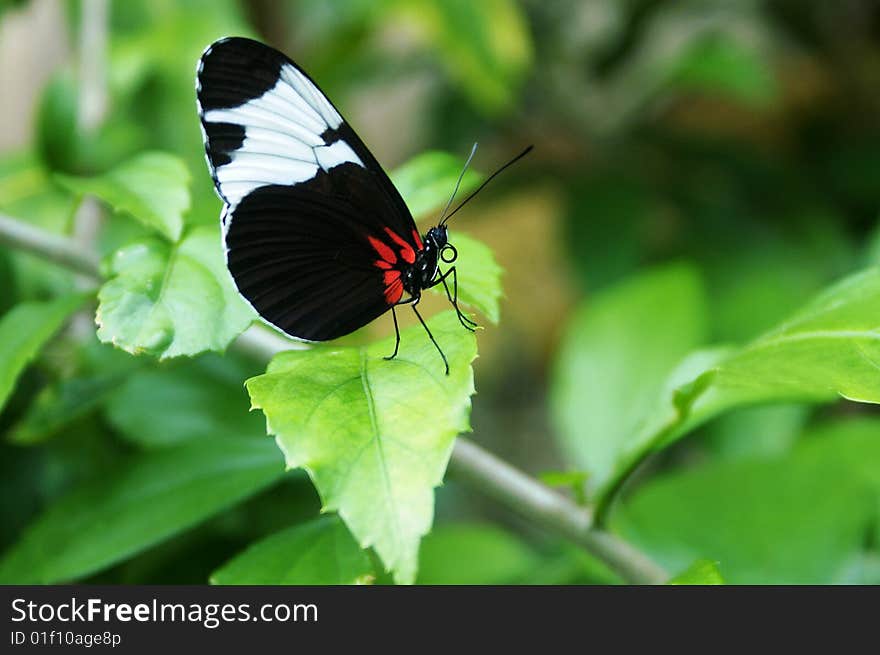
top-left (0, 0), bottom-right (880, 584)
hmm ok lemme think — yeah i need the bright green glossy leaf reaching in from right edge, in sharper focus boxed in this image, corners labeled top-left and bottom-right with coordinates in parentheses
top-left (603, 269), bottom-right (880, 508)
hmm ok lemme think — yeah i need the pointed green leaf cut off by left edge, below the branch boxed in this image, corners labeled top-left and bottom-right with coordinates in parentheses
top-left (0, 295), bottom-right (86, 409)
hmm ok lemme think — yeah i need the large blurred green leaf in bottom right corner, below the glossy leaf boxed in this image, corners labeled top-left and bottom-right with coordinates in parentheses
top-left (613, 419), bottom-right (880, 584)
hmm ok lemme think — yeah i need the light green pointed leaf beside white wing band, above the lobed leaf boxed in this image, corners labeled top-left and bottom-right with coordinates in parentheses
top-left (56, 152), bottom-right (190, 242)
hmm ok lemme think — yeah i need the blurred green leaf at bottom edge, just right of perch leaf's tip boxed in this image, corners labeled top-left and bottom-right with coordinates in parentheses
top-left (418, 524), bottom-right (538, 585)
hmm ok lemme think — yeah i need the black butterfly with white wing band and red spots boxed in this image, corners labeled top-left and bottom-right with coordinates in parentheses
top-left (196, 37), bottom-right (528, 375)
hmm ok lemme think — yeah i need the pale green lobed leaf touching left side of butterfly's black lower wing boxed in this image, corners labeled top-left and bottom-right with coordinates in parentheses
top-left (95, 227), bottom-right (254, 359)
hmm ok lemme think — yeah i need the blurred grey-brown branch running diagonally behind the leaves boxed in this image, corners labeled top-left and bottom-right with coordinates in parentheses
top-left (0, 215), bottom-right (669, 584)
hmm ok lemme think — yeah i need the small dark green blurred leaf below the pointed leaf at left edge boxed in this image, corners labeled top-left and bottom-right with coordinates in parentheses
top-left (9, 375), bottom-right (121, 445)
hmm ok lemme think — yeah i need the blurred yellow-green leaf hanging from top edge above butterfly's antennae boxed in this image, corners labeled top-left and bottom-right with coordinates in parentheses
top-left (393, 0), bottom-right (532, 113)
